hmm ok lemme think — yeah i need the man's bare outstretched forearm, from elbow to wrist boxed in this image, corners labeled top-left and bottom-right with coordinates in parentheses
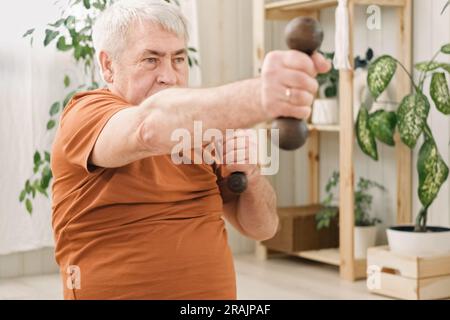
top-left (135, 79), bottom-right (267, 155)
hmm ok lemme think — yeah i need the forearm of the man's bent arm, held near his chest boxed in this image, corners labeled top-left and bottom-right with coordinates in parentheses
top-left (236, 175), bottom-right (278, 240)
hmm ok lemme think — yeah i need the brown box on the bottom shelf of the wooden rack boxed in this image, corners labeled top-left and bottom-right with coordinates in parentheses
top-left (262, 205), bottom-right (339, 253)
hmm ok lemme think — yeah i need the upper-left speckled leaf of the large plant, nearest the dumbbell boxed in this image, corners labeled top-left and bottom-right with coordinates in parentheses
top-left (367, 55), bottom-right (397, 99)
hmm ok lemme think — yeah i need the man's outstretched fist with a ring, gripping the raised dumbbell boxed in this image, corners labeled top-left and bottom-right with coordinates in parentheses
top-left (261, 50), bottom-right (331, 119)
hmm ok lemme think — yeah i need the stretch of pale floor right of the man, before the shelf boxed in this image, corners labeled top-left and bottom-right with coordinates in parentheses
top-left (235, 255), bottom-right (387, 300)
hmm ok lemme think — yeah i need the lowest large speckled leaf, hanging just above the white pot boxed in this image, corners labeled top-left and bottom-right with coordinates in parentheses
top-left (417, 140), bottom-right (448, 207)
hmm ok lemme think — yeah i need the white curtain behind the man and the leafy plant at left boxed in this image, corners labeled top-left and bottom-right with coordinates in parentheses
top-left (0, 0), bottom-right (201, 255)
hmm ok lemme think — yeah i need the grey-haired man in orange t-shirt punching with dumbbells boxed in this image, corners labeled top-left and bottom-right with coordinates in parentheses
top-left (52, 0), bottom-right (329, 299)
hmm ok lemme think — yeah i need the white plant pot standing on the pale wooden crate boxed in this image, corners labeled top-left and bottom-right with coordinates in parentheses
top-left (387, 226), bottom-right (450, 257)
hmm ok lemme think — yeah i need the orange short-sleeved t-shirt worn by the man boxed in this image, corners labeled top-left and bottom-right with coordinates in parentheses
top-left (51, 89), bottom-right (236, 299)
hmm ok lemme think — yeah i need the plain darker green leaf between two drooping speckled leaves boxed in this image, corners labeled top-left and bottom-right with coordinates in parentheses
top-left (369, 110), bottom-right (397, 146)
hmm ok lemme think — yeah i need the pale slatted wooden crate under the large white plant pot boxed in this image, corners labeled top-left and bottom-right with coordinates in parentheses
top-left (367, 247), bottom-right (450, 300)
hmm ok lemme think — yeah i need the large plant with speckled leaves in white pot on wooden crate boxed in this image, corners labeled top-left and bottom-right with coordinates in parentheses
top-left (356, 43), bottom-right (450, 256)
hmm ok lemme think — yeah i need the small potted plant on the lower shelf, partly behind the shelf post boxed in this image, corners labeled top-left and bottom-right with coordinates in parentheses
top-left (316, 172), bottom-right (385, 259)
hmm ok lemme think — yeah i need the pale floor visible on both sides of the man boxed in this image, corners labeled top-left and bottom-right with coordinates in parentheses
top-left (0, 255), bottom-right (384, 300)
